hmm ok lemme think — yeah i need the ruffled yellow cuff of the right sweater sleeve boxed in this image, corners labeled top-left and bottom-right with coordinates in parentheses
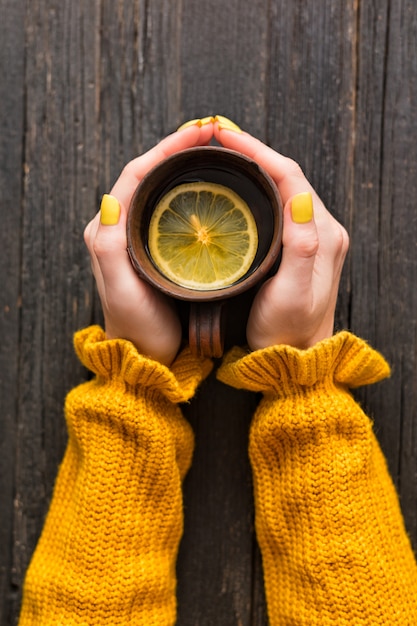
top-left (217, 331), bottom-right (390, 395)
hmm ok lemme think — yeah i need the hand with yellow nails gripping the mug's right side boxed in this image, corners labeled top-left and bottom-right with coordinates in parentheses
top-left (214, 121), bottom-right (349, 350)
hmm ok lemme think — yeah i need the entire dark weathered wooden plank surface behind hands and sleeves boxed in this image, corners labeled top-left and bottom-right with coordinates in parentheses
top-left (0, 0), bottom-right (417, 626)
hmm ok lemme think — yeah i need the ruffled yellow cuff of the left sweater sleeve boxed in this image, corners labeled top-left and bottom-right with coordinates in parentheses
top-left (74, 326), bottom-right (212, 403)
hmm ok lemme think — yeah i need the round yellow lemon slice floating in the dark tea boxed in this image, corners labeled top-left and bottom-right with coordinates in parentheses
top-left (148, 182), bottom-right (258, 291)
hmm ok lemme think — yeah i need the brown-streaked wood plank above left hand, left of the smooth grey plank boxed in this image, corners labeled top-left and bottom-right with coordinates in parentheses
top-left (98, 0), bottom-right (181, 166)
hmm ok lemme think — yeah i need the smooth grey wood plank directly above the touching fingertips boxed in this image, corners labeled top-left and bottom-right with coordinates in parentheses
top-left (181, 0), bottom-right (269, 138)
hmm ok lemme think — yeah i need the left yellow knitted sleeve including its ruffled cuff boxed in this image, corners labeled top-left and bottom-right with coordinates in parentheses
top-left (19, 327), bottom-right (210, 626)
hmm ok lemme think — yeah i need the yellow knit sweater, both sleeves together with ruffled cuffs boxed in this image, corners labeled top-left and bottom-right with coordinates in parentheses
top-left (19, 327), bottom-right (417, 626)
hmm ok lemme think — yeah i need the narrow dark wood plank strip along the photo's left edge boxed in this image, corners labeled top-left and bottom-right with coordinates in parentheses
top-left (0, 0), bottom-right (25, 624)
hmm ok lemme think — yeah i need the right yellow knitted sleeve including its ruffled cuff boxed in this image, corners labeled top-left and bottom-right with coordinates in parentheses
top-left (219, 332), bottom-right (417, 626)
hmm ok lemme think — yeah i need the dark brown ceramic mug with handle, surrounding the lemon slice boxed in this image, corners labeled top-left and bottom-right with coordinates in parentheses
top-left (127, 146), bottom-right (283, 357)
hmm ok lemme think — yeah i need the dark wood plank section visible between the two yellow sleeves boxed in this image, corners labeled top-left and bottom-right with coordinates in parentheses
top-left (178, 377), bottom-right (256, 626)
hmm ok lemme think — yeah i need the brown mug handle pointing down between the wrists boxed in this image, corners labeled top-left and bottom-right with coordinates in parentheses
top-left (189, 300), bottom-right (225, 359)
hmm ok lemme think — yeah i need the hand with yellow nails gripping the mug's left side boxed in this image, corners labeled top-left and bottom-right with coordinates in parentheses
top-left (84, 120), bottom-right (213, 365)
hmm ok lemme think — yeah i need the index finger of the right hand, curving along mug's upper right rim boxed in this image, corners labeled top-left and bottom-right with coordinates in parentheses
top-left (214, 124), bottom-right (318, 204)
